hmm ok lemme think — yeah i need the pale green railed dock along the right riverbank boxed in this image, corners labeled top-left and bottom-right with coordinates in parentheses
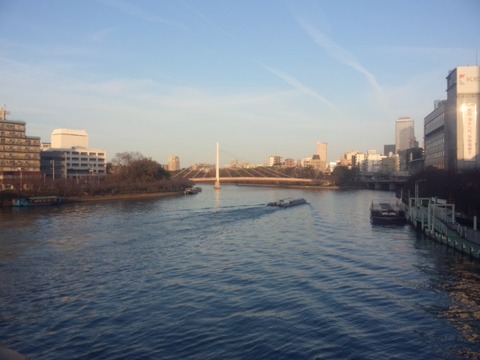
top-left (407, 198), bottom-right (480, 259)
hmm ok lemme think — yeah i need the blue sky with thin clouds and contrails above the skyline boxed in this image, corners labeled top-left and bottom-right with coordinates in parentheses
top-left (0, 0), bottom-right (480, 166)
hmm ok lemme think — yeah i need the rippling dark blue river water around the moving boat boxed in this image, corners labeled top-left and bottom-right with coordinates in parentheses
top-left (0, 186), bottom-right (480, 360)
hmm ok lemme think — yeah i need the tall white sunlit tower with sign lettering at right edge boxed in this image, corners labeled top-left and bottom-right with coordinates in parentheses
top-left (445, 66), bottom-right (480, 172)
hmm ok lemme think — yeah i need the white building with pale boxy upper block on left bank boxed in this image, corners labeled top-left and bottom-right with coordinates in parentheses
top-left (41, 129), bottom-right (106, 179)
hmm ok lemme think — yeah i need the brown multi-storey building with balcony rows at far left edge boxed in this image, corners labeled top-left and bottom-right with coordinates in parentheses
top-left (0, 108), bottom-right (40, 189)
